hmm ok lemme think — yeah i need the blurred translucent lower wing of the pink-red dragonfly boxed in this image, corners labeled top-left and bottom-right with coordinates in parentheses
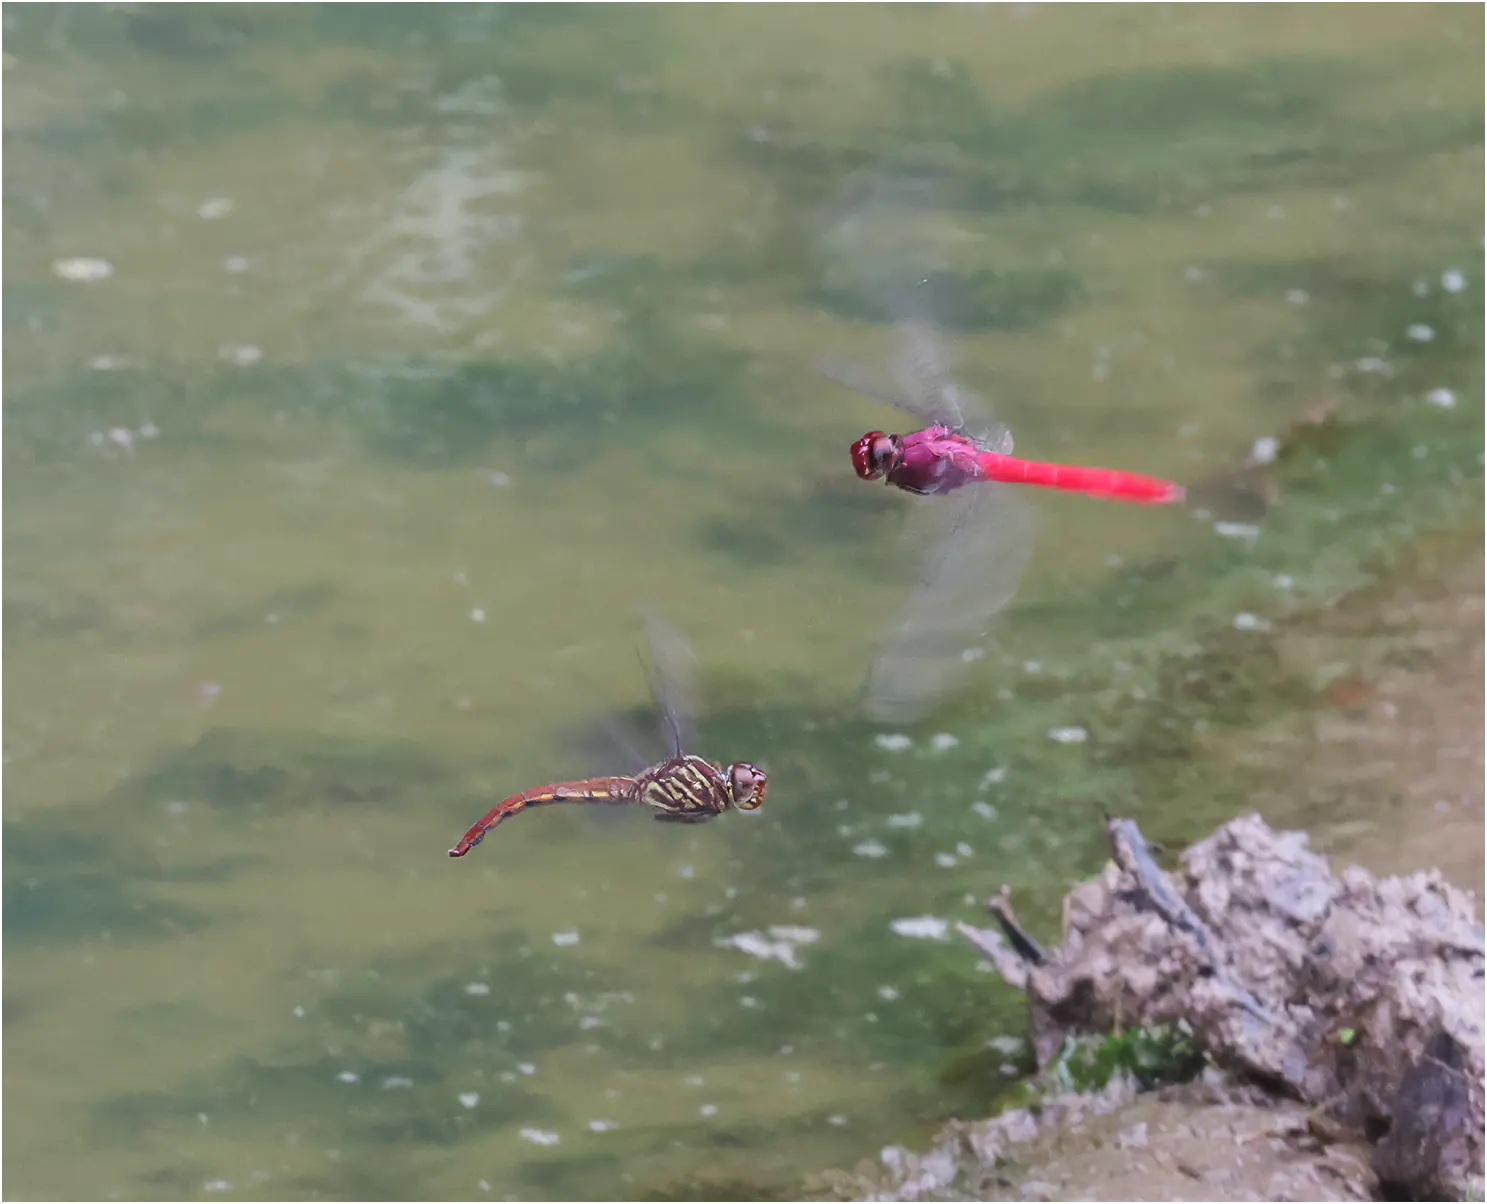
top-left (862, 485), bottom-right (1033, 722)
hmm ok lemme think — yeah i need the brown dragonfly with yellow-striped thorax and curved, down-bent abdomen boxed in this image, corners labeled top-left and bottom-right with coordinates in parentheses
top-left (449, 614), bottom-right (769, 858)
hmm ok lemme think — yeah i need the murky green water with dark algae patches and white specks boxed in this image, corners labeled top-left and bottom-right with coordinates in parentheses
top-left (4, 4), bottom-right (1483, 1198)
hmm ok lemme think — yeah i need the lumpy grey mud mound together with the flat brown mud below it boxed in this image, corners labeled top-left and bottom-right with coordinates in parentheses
top-left (831, 816), bottom-right (1484, 1200)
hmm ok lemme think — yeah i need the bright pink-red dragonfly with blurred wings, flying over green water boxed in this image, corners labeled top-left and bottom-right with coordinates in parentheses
top-left (816, 146), bottom-right (1184, 722)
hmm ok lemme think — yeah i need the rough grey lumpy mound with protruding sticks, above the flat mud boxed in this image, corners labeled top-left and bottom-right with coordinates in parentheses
top-left (959, 816), bottom-right (1487, 1200)
